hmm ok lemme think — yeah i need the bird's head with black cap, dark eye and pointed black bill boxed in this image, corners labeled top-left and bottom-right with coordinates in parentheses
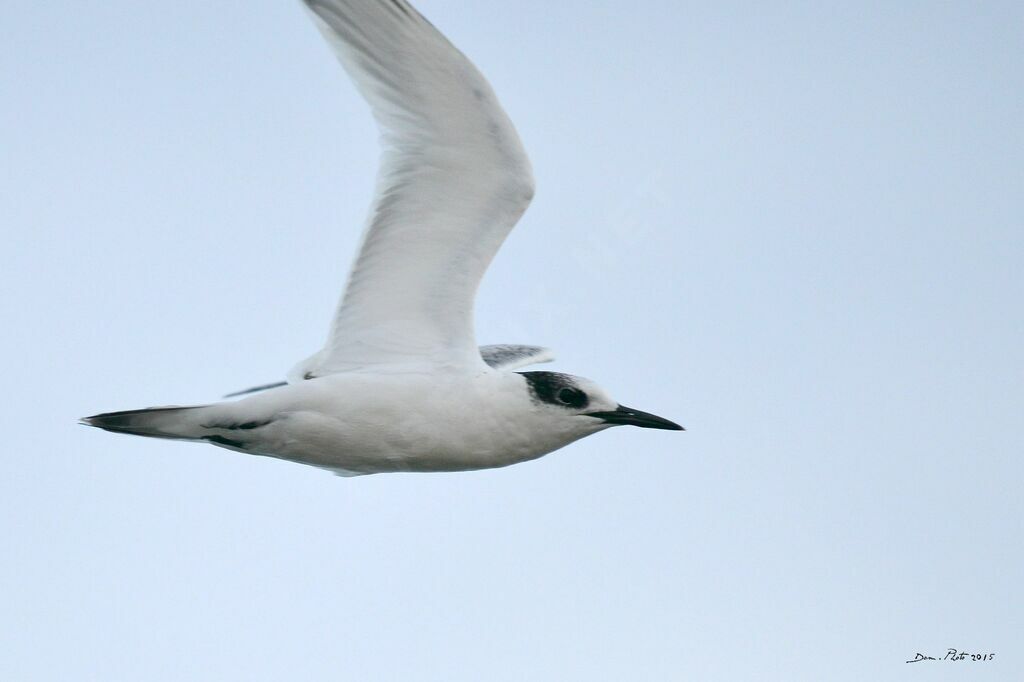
top-left (519, 372), bottom-right (683, 431)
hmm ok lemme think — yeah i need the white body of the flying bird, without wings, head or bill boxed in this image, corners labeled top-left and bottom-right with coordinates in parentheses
top-left (104, 368), bottom-right (615, 475)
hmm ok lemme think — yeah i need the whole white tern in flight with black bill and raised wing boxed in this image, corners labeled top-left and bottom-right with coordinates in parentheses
top-left (82, 0), bottom-right (682, 476)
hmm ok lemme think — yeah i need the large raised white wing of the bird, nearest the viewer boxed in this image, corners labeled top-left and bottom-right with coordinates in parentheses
top-left (290, 0), bottom-right (534, 380)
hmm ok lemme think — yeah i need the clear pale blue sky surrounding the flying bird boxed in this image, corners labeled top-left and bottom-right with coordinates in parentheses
top-left (0, 0), bottom-right (1024, 682)
